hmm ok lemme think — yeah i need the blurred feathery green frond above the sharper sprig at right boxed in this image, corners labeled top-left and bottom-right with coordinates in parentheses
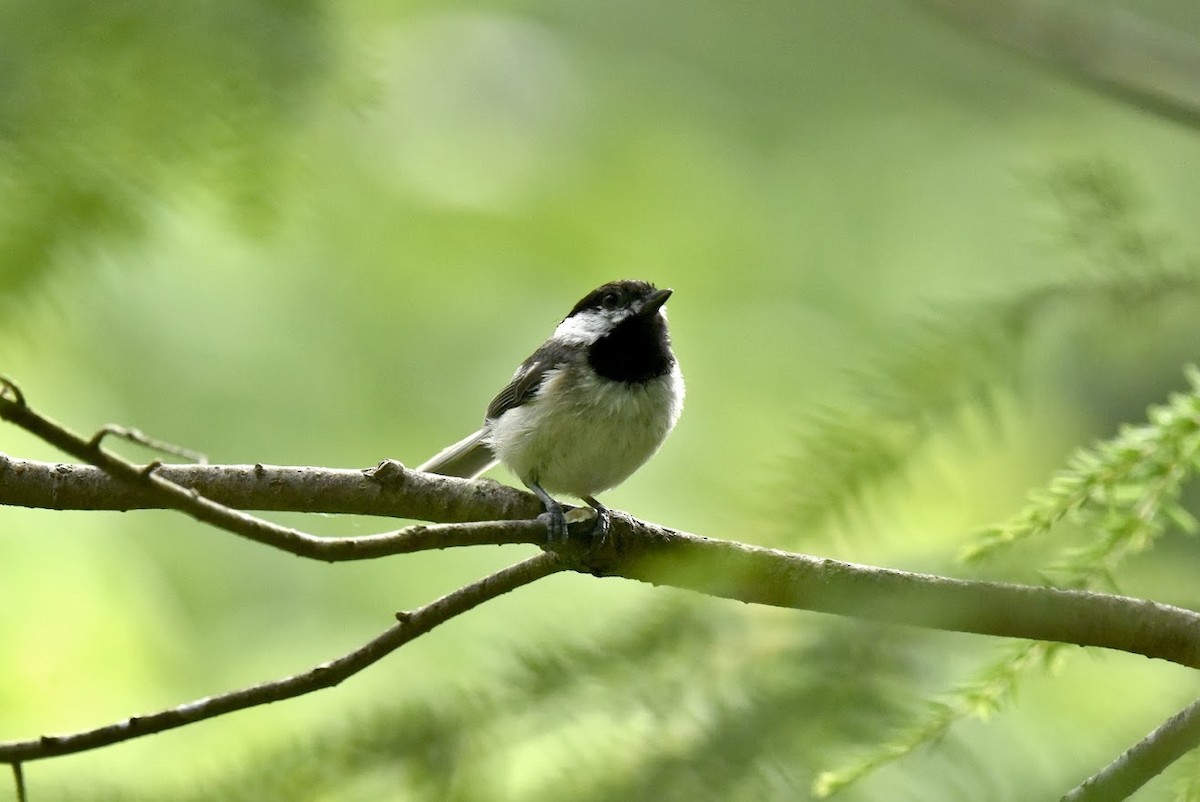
top-left (780, 161), bottom-right (1200, 542)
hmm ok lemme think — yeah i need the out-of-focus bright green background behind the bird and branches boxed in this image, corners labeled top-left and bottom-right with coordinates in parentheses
top-left (0, 0), bottom-right (1200, 802)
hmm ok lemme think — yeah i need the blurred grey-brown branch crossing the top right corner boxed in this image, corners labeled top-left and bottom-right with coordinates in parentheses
top-left (916, 0), bottom-right (1200, 128)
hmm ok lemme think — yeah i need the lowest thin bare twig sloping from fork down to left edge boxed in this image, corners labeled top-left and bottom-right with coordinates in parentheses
top-left (0, 553), bottom-right (564, 766)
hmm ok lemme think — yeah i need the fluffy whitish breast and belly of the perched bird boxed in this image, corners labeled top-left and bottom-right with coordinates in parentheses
top-left (488, 364), bottom-right (684, 498)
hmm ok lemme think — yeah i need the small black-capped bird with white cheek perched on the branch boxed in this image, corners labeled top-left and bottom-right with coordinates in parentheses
top-left (416, 279), bottom-right (685, 543)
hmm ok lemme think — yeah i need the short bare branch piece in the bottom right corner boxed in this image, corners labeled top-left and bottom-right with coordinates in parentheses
top-left (1062, 700), bottom-right (1200, 802)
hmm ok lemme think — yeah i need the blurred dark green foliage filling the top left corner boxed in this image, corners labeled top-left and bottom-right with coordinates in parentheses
top-left (0, 0), bottom-right (330, 298)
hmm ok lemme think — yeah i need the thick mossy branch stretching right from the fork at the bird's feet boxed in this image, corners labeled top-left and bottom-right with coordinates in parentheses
top-left (584, 516), bottom-right (1200, 668)
